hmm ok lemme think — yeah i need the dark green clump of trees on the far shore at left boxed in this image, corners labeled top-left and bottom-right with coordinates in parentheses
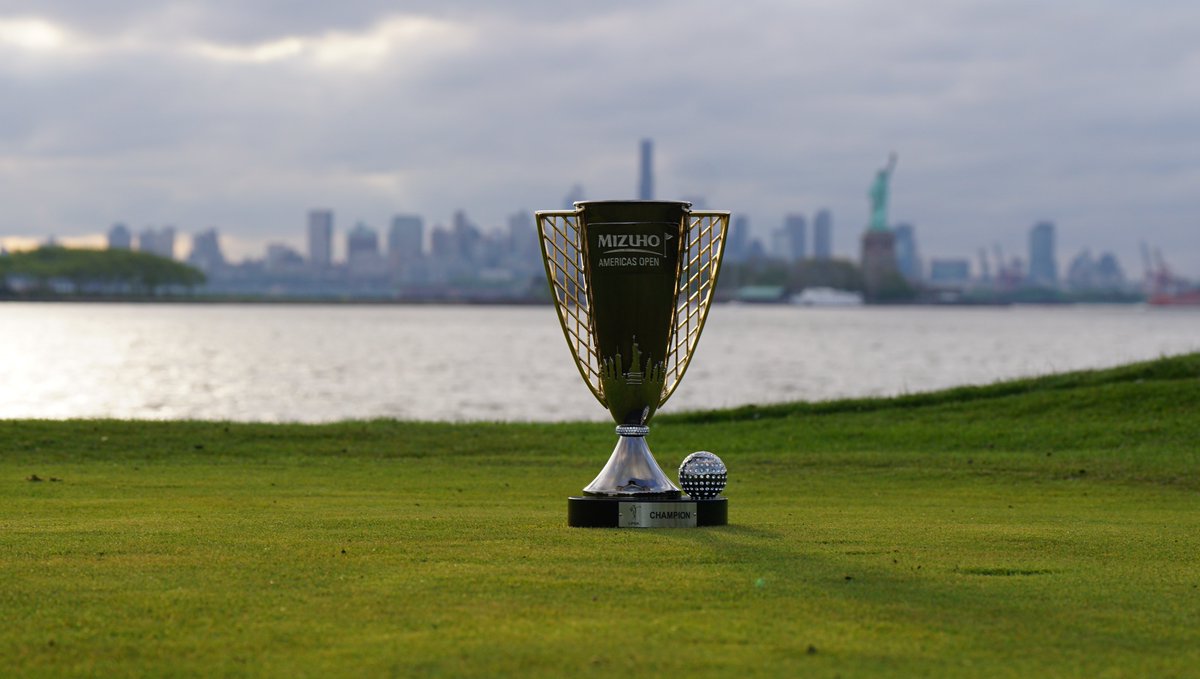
top-left (0, 246), bottom-right (204, 295)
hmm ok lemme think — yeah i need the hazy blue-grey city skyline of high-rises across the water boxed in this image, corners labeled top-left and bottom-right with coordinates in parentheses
top-left (89, 185), bottom-right (1171, 287)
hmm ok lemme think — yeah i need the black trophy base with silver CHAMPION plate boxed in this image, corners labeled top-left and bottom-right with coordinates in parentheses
top-left (566, 497), bottom-right (730, 528)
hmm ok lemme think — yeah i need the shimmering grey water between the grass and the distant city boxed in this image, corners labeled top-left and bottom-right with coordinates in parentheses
top-left (0, 304), bottom-right (1200, 422)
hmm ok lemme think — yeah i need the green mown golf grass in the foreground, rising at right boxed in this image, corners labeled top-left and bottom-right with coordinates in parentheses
top-left (0, 354), bottom-right (1200, 678)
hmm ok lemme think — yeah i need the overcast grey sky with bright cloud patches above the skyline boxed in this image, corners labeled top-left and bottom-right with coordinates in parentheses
top-left (0, 0), bottom-right (1200, 276)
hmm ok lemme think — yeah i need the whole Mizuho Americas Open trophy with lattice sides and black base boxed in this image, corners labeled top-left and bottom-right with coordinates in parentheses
top-left (536, 200), bottom-right (730, 528)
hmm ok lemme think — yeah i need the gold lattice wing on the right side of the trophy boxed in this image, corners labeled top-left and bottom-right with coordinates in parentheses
top-left (659, 211), bottom-right (730, 405)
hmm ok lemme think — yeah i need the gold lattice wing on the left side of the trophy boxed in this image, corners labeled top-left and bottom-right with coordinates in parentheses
top-left (538, 210), bottom-right (608, 407)
